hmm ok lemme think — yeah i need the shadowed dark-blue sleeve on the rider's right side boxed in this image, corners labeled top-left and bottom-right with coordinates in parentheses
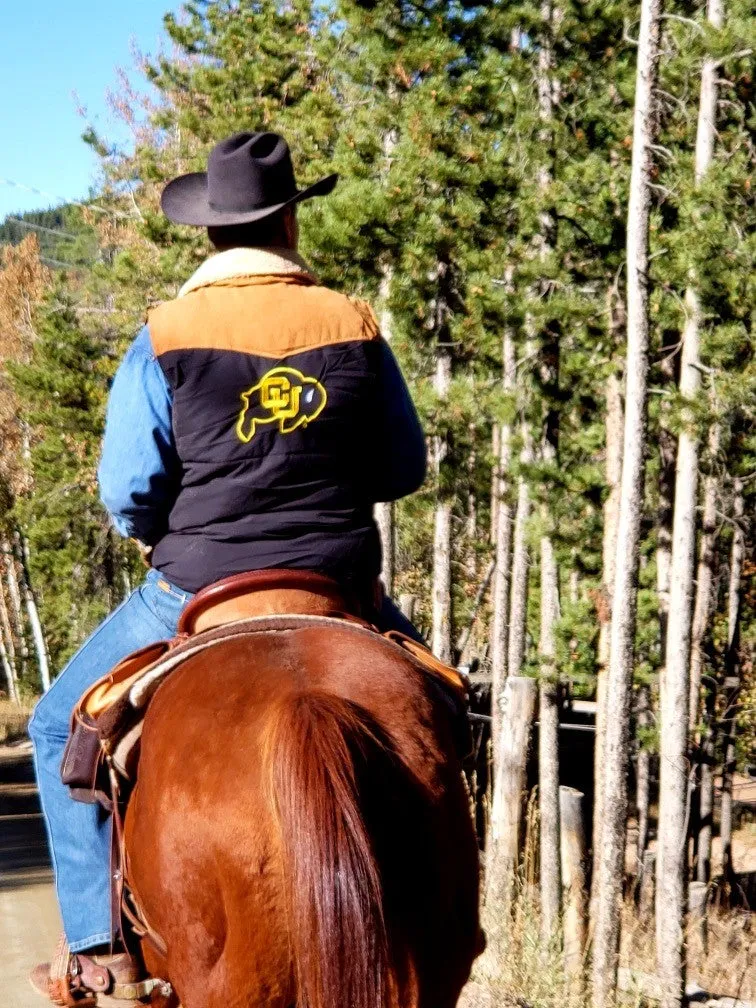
top-left (371, 340), bottom-right (427, 502)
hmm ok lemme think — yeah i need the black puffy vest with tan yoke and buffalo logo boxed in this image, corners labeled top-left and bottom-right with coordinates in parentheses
top-left (148, 272), bottom-right (380, 592)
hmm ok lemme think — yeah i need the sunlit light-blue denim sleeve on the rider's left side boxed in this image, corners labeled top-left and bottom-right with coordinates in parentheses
top-left (98, 326), bottom-right (180, 545)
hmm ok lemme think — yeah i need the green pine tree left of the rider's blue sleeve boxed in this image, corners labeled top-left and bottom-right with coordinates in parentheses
top-left (10, 283), bottom-right (126, 668)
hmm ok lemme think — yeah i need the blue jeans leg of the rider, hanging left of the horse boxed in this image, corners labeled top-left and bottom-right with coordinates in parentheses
top-left (29, 571), bottom-right (192, 952)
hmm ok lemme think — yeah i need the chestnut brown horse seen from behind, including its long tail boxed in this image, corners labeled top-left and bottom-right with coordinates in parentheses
top-left (126, 626), bottom-right (482, 1008)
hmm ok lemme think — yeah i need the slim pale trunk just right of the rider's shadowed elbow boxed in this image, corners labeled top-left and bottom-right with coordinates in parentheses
top-left (431, 347), bottom-right (452, 661)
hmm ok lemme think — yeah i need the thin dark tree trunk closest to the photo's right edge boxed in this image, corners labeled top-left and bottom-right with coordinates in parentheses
top-left (720, 479), bottom-right (746, 884)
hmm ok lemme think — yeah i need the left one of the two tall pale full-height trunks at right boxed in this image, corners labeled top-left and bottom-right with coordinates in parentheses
top-left (593, 0), bottom-right (661, 1008)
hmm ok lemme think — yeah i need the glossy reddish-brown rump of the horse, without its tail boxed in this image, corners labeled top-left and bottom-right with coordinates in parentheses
top-left (127, 628), bottom-right (477, 1008)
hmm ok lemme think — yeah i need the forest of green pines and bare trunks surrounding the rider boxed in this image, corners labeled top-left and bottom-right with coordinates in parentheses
top-left (0, 0), bottom-right (756, 1008)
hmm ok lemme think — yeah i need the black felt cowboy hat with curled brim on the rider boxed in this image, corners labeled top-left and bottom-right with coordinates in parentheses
top-left (160, 133), bottom-right (339, 228)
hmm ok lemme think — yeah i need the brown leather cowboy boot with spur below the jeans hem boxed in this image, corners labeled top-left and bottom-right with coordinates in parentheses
top-left (29, 936), bottom-right (170, 1008)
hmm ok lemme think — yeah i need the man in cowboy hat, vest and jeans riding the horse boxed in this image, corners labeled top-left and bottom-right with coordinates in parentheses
top-left (29, 133), bottom-right (425, 1006)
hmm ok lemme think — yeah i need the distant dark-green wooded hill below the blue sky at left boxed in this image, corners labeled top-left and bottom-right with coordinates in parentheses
top-left (0, 205), bottom-right (98, 268)
